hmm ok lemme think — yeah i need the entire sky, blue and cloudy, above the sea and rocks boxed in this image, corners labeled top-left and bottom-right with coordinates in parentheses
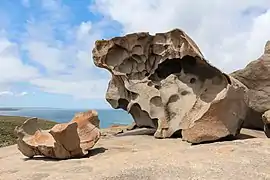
top-left (0, 0), bottom-right (270, 109)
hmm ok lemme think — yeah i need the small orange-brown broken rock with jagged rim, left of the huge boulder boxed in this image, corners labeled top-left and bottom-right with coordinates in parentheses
top-left (15, 111), bottom-right (100, 159)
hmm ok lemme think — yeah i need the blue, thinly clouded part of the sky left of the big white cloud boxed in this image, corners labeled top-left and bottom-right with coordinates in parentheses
top-left (0, 0), bottom-right (118, 108)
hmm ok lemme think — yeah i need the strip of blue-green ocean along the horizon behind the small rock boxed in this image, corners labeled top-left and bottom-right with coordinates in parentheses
top-left (0, 108), bottom-right (133, 128)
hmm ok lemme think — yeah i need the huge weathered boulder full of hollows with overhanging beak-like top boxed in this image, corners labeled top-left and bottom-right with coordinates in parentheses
top-left (93, 29), bottom-right (247, 143)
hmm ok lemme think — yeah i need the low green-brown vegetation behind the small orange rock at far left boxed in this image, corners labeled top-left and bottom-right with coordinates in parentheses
top-left (0, 116), bottom-right (56, 147)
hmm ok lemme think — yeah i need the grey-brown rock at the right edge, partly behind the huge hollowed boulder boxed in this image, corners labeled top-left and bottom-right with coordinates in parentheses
top-left (231, 41), bottom-right (270, 129)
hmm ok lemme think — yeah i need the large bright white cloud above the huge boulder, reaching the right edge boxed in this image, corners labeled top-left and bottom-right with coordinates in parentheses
top-left (92, 0), bottom-right (270, 72)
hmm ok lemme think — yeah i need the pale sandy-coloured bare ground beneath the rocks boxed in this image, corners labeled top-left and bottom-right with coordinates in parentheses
top-left (0, 130), bottom-right (270, 180)
